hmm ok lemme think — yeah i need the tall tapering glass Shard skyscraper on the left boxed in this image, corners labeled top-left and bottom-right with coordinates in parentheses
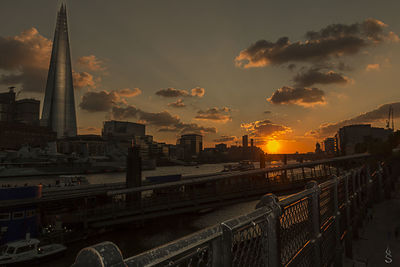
top-left (41, 5), bottom-right (76, 138)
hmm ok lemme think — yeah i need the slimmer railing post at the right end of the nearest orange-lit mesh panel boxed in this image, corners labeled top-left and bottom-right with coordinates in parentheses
top-left (306, 181), bottom-right (321, 266)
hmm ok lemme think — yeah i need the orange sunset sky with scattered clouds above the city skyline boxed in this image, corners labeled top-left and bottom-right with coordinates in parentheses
top-left (0, 0), bottom-right (400, 153)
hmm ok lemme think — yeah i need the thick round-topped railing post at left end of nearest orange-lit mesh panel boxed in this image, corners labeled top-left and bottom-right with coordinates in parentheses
top-left (256, 193), bottom-right (282, 266)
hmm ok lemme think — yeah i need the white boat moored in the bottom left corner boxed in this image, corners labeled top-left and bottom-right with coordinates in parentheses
top-left (0, 238), bottom-right (67, 266)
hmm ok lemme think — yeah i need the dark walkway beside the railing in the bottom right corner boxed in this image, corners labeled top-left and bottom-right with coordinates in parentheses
top-left (345, 183), bottom-right (400, 267)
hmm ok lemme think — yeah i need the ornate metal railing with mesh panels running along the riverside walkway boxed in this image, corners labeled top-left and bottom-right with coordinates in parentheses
top-left (73, 160), bottom-right (397, 267)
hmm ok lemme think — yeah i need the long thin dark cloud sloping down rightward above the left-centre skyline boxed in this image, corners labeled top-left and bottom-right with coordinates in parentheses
top-left (112, 105), bottom-right (217, 134)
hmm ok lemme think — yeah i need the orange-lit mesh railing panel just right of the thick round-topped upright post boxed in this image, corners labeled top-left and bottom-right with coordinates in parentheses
top-left (280, 196), bottom-right (312, 265)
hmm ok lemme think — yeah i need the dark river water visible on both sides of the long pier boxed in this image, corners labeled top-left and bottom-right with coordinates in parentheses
top-left (0, 163), bottom-right (284, 267)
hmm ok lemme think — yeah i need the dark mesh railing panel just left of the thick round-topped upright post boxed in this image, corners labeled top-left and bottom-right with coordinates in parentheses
top-left (231, 218), bottom-right (268, 267)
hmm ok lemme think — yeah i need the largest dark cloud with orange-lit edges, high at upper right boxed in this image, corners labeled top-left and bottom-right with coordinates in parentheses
top-left (235, 19), bottom-right (399, 68)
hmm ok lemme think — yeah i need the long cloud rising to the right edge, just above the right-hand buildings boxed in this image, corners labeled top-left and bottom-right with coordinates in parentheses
top-left (308, 102), bottom-right (400, 138)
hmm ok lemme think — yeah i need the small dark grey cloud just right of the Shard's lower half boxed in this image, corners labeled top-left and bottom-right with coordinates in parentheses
top-left (79, 91), bottom-right (120, 112)
